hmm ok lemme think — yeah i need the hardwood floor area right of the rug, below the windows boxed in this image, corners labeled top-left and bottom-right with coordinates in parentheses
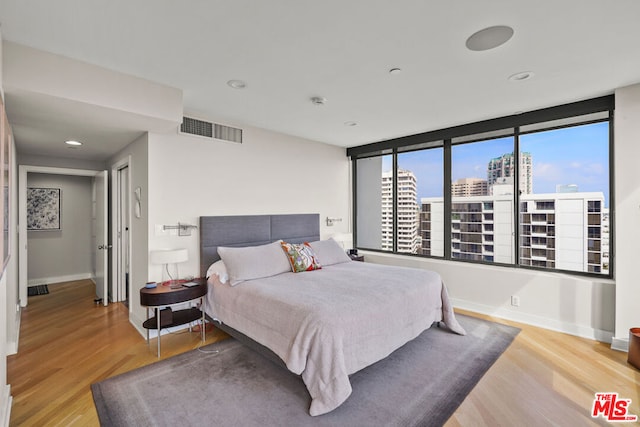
top-left (446, 310), bottom-right (640, 427)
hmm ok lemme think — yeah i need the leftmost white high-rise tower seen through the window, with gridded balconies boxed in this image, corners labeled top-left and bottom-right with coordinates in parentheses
top-left (381, 169), bottom-right (421, 254)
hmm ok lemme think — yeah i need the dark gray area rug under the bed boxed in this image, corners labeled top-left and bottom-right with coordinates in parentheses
top-left (91, 315), bottom-right (519, 426)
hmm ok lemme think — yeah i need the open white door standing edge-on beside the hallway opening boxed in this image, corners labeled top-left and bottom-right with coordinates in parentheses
top-left (93, 171), bottom-right (111, 305)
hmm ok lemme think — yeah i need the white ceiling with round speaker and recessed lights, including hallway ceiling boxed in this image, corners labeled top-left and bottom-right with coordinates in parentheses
top-left (0, 0), bottom-right (640, 159)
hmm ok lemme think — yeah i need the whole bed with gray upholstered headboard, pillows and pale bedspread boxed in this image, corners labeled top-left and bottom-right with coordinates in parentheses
top-left (200, 214), bottom-right (465, 416)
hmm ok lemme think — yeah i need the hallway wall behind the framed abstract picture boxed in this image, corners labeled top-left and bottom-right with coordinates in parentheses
top-left (27, 173), bottom-right (93, 285)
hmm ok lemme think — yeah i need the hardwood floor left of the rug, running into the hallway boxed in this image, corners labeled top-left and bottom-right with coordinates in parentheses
top-left (7, 280), bottom-right (227, 426)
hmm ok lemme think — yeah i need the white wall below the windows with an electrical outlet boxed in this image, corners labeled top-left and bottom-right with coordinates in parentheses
top-left (363, 252), bottom-right (615, 342)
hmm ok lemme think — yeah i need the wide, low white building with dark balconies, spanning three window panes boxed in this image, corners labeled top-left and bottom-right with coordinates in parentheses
top-left (420, 192), bottom-right (609, 274)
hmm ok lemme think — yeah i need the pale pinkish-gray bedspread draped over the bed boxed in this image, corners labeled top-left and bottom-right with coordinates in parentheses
top-left (205, 262), bottom-right (465, 415)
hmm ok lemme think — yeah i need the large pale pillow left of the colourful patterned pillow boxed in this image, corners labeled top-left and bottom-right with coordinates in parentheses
top-left (218, 242), bottom-right (291, 286)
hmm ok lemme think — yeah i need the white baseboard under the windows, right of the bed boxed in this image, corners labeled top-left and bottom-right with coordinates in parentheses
top-left (451, 298), bottom-right (613, 343)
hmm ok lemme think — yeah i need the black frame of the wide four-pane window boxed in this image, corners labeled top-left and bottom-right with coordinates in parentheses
top-left (346, 95), bottom-right (615, 278)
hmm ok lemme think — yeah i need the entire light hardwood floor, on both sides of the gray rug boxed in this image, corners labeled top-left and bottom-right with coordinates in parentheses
top-left (7, 281), bottom-right (640, 426)
